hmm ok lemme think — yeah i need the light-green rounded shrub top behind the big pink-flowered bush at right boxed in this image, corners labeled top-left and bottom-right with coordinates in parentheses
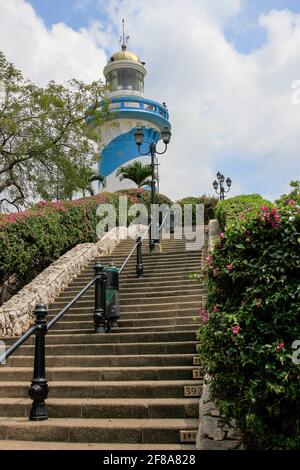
top-left (216, 194), bottom-right (272, 230)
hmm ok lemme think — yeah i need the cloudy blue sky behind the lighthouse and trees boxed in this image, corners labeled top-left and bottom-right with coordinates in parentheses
top-left (0, 0), bottom-right (300, 199)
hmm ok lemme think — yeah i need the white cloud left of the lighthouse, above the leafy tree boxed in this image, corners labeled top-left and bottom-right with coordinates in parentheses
top-left (0, 0), bottom-right (106, 84)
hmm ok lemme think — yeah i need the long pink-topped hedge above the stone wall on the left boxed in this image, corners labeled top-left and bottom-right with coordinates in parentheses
top-left (0, 190), bottom-right (171, 304)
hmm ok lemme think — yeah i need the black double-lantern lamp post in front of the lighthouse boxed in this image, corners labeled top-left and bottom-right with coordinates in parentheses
top-left (134, 127), bottom-right (172, 250)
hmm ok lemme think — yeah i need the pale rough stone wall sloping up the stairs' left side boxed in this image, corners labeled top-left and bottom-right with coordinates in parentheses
top-left (0, 225), bottom-right (146, 336)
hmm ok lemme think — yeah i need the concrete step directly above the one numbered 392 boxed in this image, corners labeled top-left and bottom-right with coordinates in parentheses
top-left (0, 365), bottom-right (202, 382)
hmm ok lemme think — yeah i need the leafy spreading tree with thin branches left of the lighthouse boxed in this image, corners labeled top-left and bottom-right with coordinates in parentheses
top-left (0, 51), bottom-right (109, 210)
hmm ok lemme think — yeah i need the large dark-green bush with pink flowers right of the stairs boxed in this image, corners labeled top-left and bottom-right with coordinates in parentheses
top-left (199, 190), bottom-right (300, 449)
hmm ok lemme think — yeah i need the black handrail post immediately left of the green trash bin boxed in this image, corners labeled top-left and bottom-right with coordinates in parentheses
top-left (94, 261), bottom-right (106, 333)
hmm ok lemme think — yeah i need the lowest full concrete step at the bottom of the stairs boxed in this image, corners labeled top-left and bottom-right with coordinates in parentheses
top-left (0, 418), bottom-right (198, 444)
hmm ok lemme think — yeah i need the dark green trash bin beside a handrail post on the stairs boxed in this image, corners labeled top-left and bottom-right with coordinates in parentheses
top-left (104, 263), bottom-right (120, 332)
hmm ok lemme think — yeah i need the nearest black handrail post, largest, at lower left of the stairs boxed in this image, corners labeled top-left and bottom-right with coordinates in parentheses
top-left (28, 304), bottom-right (48, 421)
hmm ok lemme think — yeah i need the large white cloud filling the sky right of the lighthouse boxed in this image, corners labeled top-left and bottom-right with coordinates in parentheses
top-left (101, 0), bottom-right (300, 196)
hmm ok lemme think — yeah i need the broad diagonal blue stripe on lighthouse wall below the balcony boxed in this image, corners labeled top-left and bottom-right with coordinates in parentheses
top-left (99, 127), bottom-right (160, 176)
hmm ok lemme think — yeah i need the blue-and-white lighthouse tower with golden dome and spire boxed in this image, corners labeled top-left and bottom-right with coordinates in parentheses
top-left (99, 20), bottom-right (171, 191)
